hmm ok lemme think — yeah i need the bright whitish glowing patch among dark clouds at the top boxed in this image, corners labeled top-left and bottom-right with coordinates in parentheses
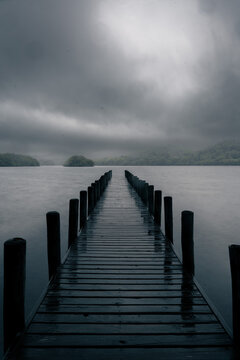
top-left (100, 0), bottom-right (218, 100)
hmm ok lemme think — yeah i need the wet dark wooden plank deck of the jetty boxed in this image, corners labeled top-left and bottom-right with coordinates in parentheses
top-left (8, 174), bottom-right (237, 360)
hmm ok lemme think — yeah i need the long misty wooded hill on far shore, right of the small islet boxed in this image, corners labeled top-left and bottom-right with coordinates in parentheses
top-left (96, 141), bottom-right (240, 165)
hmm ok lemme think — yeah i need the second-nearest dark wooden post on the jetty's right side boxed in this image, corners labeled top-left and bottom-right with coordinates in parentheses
top-left (181, 210), bottom-right (194, 275)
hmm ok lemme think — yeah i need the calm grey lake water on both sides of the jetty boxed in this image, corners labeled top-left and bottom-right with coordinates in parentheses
top-left (0, 166), bottom-right (240, 354)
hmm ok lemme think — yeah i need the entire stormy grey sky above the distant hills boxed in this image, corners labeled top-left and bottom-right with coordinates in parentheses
top-left (0, 0), bottom-right (240, 160)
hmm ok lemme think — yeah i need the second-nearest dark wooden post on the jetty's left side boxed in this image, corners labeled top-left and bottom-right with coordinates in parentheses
top-left (46, 211), bottom-right (61, 279)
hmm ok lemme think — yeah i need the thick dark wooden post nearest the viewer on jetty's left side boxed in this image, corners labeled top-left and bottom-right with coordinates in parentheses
top-left (3, 238), bottom-right (26, 352)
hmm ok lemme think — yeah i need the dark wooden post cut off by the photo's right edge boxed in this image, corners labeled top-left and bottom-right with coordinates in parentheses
top-left (229, 245), bottom-right (240, 346)
